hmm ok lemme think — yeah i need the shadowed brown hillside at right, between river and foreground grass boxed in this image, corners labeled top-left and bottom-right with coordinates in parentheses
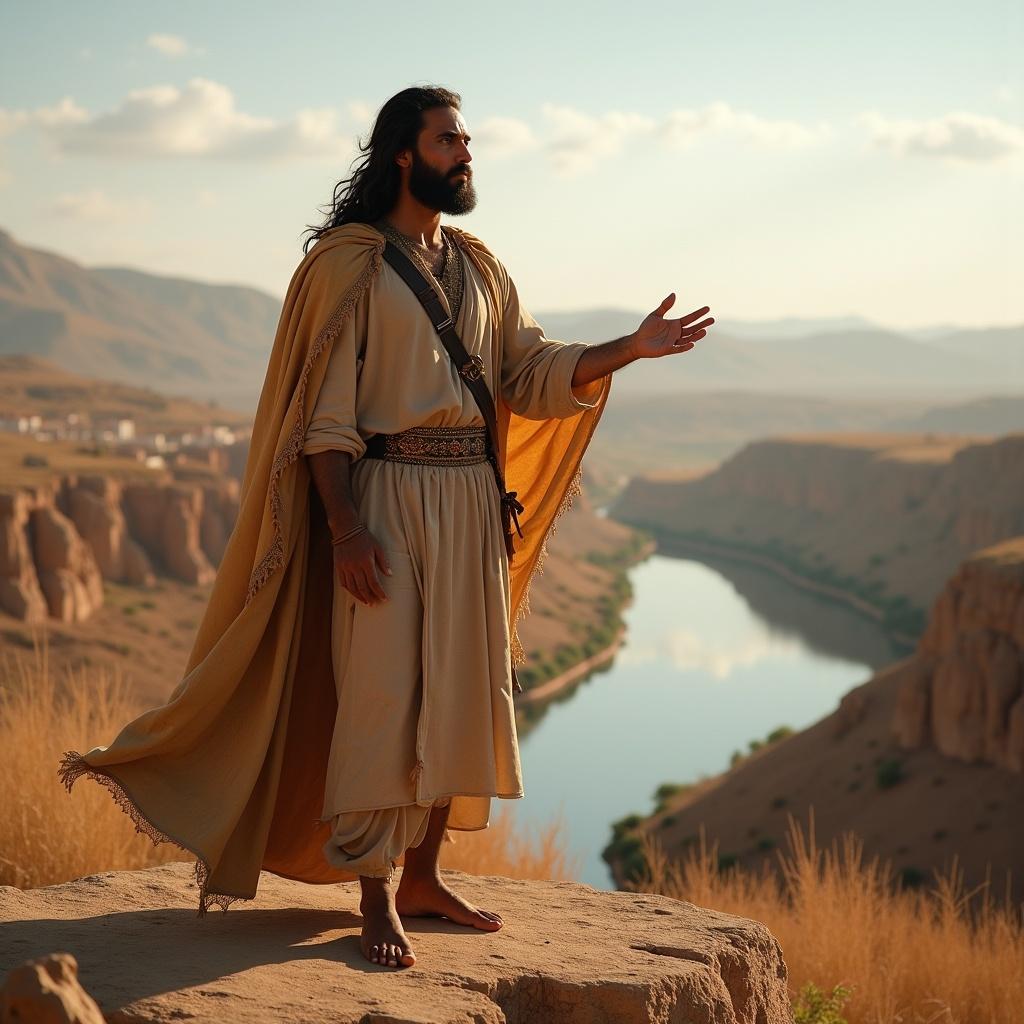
top-left (610, 537), bottom-right (1024, 898)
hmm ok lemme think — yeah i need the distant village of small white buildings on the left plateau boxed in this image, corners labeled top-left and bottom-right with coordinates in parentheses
top-left (0, 413), bottom-right (247, 470)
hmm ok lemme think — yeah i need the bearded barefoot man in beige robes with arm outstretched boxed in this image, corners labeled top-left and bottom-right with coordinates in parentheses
top-left (60, 88), bottom-right (713, 967)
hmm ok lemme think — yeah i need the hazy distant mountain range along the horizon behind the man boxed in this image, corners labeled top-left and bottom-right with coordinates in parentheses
top-left (0, 230), bottom-right (1024, 412)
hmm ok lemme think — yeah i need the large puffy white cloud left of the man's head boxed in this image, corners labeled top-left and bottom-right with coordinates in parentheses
top-left (40, 78), bottom-right (351, 160)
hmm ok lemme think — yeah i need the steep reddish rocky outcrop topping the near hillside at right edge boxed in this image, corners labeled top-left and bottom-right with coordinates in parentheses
top-left (893, 538), bottom-right (1024, 772)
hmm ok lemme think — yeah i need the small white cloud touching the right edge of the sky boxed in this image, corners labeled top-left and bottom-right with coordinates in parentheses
top-left (857, 111), bottom-right (1024, 163)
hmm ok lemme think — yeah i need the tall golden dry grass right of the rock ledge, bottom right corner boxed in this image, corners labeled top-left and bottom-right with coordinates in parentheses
top-left (640, 814), bottom-right (1024, 1024)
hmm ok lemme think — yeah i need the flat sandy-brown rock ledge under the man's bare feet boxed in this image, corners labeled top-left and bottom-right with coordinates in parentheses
top-left (0, 861), bottom-right (792, 1024)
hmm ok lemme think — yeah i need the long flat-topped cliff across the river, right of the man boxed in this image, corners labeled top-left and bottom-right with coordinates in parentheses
top-left (611, 434), bottom-right (1024, 634)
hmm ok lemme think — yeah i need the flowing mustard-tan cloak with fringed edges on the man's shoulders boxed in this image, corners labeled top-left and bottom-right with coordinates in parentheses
top-left (58, 223), bottom-right (611, 914)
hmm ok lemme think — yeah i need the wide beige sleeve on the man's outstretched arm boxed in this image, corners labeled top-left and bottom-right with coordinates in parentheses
top-left (501, 272), bottom-right (602, 420)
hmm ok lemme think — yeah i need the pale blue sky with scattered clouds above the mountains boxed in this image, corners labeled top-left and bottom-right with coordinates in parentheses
top-left (0, 0), bottom-right (1024, 327)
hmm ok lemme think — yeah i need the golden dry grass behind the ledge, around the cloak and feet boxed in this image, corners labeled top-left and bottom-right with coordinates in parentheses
top-left (0, 634), bottom-right (574, 889)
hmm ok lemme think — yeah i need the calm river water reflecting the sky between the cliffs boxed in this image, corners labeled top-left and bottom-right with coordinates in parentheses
top-left (509, 549), bottom-right (905, 889)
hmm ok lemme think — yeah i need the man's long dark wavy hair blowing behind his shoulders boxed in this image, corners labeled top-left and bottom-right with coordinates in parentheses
top-left (302, 85), bottom-right (462, 253)
